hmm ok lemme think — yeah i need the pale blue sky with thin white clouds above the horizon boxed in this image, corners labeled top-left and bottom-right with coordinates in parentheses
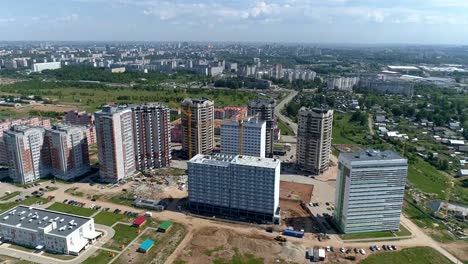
top-left (0, 0), bottom-right (468, 45)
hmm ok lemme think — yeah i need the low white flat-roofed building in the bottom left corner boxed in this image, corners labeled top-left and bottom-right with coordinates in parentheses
top-left (0, 205), bottom-right (102, 255)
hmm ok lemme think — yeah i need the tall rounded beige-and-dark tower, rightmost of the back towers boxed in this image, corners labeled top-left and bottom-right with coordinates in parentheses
top-left (296, 107), bottom-right (333, 174)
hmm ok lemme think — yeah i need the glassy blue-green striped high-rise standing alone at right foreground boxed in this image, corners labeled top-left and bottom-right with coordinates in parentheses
top-left (334, 150), bottom-right (408, 233)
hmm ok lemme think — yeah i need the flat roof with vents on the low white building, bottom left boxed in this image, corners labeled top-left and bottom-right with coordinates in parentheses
top-left (0, 205), bottom-right (91, 237)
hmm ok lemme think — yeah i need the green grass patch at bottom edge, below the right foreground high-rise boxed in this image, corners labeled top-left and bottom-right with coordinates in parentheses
top-left (360, 247), bottom-right (452, 264)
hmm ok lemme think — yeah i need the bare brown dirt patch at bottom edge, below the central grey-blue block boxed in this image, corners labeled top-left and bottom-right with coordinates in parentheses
top-left (178, 227), bottom-right (305, 264)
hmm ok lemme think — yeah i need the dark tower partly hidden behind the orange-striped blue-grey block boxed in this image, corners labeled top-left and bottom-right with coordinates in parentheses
top-left (247, 99), bottom-right (275, 157)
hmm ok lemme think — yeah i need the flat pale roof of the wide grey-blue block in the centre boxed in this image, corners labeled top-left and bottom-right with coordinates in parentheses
top-left (189, 154), bottom-right (281, 169)
